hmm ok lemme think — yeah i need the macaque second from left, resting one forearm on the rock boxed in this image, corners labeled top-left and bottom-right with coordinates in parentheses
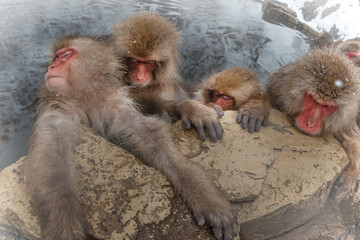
top-left (113, 13), bottom-right (223, 141)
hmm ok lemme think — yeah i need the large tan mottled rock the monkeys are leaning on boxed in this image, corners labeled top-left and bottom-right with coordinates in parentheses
top-left (0, 110), bottom-right (347, 240)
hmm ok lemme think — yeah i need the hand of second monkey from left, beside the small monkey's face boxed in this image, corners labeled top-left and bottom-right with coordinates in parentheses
top-left (178, 99), bottom-right (224, 142)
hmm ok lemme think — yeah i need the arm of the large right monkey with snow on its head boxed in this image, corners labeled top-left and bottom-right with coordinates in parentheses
top-left (333, 127), bottom-right (360, 199)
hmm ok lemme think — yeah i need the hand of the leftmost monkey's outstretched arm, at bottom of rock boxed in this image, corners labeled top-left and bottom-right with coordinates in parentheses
top-left (193, 205), bottom-right (238, 240)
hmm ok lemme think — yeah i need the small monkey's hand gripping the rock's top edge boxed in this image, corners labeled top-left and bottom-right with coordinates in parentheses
top-left (236, 102), bottom-right (270, 133)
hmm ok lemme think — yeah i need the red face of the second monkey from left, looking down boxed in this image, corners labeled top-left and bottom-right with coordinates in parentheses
top-left (127, 57), bottom-right (158, 86)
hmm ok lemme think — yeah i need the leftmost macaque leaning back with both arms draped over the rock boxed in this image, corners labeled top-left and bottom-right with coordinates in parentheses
top-left (24, 36), bottom-right (237, 240)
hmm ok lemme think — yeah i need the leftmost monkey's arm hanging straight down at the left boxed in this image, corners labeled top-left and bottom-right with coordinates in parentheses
top-left (24, 101), bottom-right (84, 239)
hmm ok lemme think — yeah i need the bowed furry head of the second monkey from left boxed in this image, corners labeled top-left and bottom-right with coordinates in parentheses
top-left (112, 13), bottom-right (180, 87)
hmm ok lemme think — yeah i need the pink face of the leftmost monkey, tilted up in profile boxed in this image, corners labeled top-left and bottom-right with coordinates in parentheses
top-left (45, 47), bottom-right (77, 90)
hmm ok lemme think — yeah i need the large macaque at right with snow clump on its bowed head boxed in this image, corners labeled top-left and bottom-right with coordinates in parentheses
top-left (267, 49), bottom-right (360, 199)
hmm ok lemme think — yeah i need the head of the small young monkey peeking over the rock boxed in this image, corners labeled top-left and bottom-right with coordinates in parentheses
top-left (202, 67), bottom-right (260, 111)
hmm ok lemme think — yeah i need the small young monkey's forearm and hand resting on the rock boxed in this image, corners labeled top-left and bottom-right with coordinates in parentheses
top-left (236, 93), bottom-right (271, 133)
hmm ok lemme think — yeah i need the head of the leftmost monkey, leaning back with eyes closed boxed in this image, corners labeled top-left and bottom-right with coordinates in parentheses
top-left (44, 36), bottom-right (121, 95)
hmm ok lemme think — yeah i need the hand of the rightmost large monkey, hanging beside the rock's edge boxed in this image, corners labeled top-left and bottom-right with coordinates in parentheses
top-left (332, 165), bottom-right (358, 200)
